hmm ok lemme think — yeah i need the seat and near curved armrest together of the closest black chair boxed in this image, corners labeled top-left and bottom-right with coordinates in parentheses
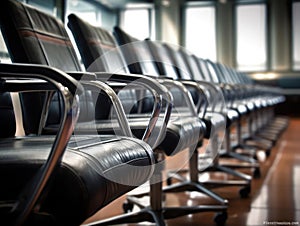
top-left (0, 64), bottom-right (154, 225)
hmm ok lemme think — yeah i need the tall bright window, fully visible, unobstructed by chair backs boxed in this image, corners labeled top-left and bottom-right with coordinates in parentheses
top-left (236, 4), bottom-right (267, 71)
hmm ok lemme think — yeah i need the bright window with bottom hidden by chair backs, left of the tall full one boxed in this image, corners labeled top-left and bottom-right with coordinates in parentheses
top-left (185, 6), bottom-right (217, 61)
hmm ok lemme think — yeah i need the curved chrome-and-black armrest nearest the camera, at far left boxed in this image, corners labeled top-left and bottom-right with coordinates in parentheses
top-left (0, 64), bottom-right (83, 225)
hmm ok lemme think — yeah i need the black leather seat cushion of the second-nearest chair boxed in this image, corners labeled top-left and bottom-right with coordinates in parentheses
top-left (44, 116), bottom-right (206, 155)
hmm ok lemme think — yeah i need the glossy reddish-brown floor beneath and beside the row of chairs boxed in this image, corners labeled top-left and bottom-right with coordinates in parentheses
top-left (87, 118), bottom-right (300, 226)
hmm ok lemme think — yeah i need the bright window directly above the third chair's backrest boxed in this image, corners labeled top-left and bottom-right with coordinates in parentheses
top-left (121, 8), bottom-right (155, 40)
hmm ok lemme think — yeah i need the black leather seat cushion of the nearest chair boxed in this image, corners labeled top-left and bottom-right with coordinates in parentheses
top-left (0, 136), bottom-right (154, 225)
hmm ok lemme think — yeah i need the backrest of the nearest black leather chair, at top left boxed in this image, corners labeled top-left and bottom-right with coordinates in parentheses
top-left (0, 0), bottom-right (81, 71)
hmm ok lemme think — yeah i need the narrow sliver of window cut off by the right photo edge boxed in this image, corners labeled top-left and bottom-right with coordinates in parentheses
top-left (292, 2), bottom-right (300, 70)
